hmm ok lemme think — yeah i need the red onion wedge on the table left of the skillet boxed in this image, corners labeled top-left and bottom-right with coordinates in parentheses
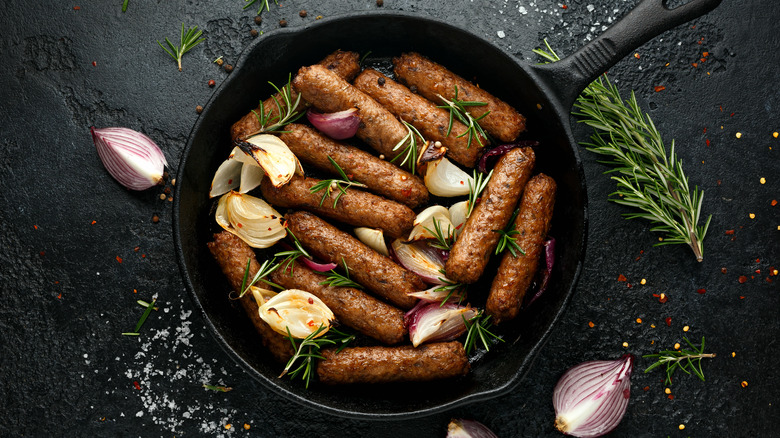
top-left (89, 126), bottom-right (168, 190)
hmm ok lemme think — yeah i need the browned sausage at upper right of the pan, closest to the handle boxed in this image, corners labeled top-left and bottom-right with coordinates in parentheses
top-left (393, 53), bottom-right (525, 142)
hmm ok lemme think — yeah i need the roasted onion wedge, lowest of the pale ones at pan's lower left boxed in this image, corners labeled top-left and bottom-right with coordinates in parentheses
top-left (259, 289), bottom-right (335, 339)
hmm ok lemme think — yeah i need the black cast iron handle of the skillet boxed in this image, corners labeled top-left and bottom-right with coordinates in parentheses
top-left (533, 0), bottom-right (721, 110)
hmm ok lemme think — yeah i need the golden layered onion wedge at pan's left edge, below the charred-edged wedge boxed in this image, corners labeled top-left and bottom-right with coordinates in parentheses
top-left (214, 191), bottom-right (287, 248)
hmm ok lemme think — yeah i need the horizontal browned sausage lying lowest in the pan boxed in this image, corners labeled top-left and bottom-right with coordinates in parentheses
top-left (317, 341), bottom-right (469, 385)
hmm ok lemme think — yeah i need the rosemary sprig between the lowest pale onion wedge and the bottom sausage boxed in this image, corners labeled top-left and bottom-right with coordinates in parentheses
top-left (279, 324), bottom-right (355, 388)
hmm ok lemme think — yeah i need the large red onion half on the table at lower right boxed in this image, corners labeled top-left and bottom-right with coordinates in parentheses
top-left (553, 354), bottom-right (634, 438)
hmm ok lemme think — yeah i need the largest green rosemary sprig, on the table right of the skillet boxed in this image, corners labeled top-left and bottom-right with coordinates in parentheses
top-left (534, 41), bottom-right (712, 261)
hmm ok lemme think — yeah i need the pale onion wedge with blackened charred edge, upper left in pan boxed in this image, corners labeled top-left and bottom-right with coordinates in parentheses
top-left (240, 134), bottom-right (303, 187)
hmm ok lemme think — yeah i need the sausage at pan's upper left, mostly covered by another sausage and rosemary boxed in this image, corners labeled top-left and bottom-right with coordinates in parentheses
top-left (230, 50), bottom-right (360, 141)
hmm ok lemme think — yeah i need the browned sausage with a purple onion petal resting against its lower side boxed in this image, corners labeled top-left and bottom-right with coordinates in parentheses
top-left (293, 65), bottom-right (416, 158)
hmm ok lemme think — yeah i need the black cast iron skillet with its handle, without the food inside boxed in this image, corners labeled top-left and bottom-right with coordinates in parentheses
top-left (173, 0), bottom-right (720, 418)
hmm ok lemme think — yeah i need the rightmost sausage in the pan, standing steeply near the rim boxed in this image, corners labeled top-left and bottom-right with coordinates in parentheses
top-left (486, 174), bottom-right (555, 324)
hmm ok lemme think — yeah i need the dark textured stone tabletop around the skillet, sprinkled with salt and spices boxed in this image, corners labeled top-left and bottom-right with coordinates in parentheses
top-left (0, 0), bottom-right (780, 437)
